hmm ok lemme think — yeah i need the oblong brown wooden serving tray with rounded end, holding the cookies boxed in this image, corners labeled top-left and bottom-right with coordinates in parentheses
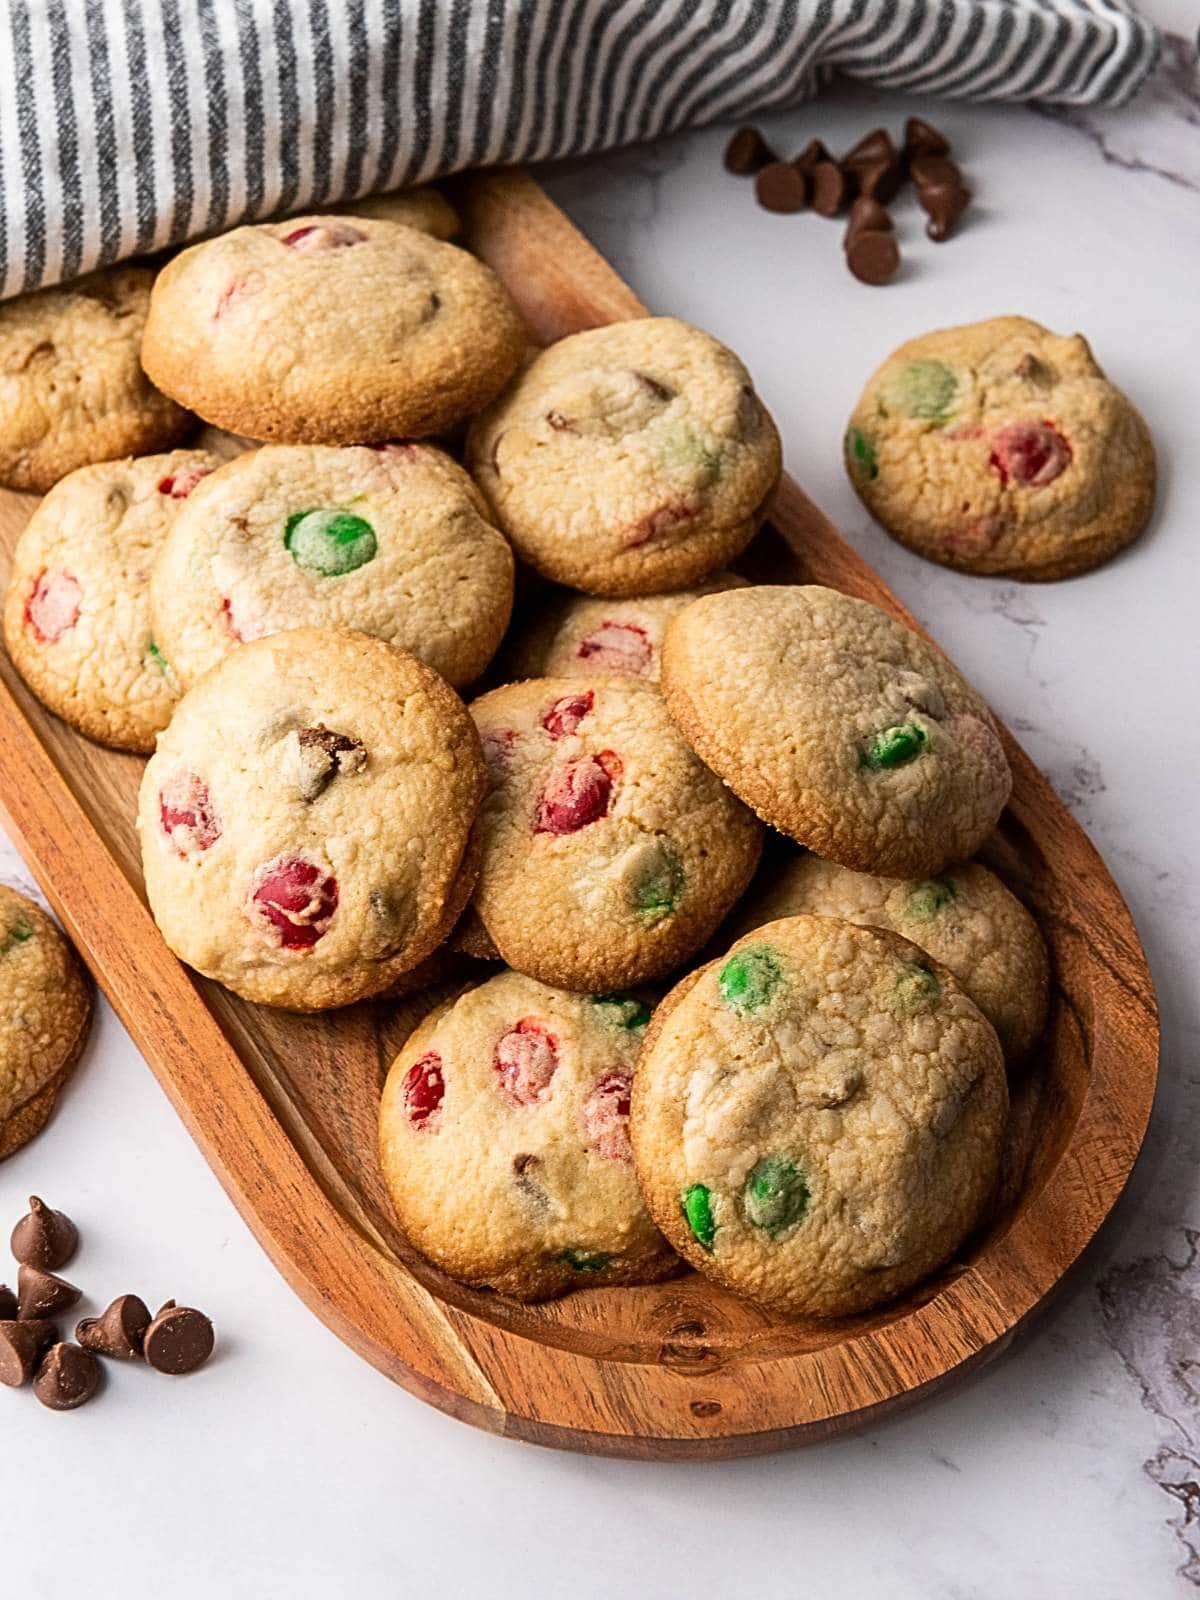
top-left (0, 173), bottom-right (1158, 1459)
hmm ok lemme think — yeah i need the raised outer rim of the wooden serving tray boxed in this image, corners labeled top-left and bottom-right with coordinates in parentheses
top-left (0, 171), bottom-right (1158, 1459)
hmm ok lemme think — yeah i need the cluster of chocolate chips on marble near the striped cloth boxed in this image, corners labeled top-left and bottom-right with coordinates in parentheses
top-left (725, 117), bottom-right (971, 283)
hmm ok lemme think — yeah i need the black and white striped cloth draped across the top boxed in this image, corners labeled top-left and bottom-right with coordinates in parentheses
top-left (0, 0), bottom-right (1158, 299)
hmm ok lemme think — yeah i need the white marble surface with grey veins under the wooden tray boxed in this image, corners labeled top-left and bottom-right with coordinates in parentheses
top-left (0, 15), bottom-right (1200, 1600)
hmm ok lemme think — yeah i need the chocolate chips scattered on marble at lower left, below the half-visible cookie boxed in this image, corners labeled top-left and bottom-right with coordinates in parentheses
top-left (0, 1195), bottom-right (213, 1411)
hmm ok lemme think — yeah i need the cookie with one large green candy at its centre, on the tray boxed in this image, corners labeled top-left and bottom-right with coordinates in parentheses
top-left (150, 445), bottom-right (512, 686)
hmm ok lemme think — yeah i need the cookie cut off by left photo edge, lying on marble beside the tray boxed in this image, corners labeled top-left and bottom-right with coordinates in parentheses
top-left (0, 885), bottom-right (91, 1160)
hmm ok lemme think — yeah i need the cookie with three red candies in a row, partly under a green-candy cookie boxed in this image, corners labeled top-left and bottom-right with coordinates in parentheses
top-left (379, 971), bottom-right (678, 1301)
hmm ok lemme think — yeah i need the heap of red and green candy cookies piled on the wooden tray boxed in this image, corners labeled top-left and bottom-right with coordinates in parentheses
top-left (5, 193), bottom-right (1046, 1317)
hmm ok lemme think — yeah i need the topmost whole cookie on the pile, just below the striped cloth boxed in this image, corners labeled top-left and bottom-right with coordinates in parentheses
top-left (142, 216), bottom-right (525, 445)
